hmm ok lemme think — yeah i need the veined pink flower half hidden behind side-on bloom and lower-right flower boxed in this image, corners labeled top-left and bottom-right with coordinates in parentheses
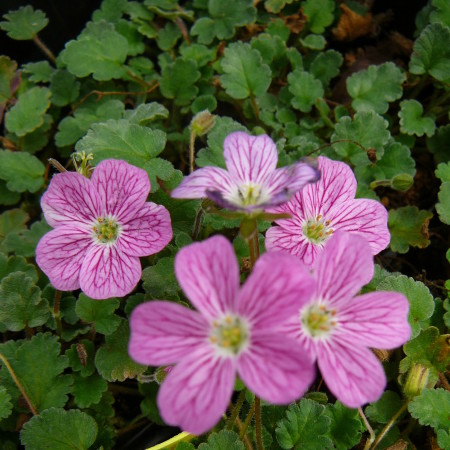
top-left (266, 156), bottom-right (390, 266)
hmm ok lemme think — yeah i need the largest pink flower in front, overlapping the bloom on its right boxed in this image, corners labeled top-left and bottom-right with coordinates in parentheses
top-left (129, 236), bottom-right (314, 434)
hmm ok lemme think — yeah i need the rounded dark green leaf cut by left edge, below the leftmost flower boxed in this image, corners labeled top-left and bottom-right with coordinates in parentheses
top-left (0, 272), bottom-right (50, 331)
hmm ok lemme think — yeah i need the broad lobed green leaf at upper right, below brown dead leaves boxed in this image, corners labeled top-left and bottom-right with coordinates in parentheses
top-left (347, 62), bottom-right (406, 114)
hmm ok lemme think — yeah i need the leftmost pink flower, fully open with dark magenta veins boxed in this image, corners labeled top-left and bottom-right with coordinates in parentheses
top-left (36, 159), bottom-right (172, 299)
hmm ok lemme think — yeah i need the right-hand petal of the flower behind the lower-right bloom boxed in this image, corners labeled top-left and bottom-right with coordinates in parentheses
top-left (326, 199), bottom-right (391, 255)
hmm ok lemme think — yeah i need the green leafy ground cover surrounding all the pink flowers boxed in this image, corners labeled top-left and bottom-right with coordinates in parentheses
top-left (0, 0), bottom-right (450, 450)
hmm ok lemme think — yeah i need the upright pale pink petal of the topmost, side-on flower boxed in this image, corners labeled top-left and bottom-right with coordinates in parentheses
top-left (223, 131), bottom-right (278, 184)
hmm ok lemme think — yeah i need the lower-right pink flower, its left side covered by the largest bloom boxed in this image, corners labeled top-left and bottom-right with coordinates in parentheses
top-left (286, 232), bottom-right (411, 408)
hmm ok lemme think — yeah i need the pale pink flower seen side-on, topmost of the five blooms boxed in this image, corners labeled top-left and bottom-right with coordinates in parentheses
top-left (172, 131), bottom-right (320, 212)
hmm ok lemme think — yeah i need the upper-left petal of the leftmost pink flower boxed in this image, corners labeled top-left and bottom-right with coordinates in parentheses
top-left (41, 172), bottom-right (102, 227)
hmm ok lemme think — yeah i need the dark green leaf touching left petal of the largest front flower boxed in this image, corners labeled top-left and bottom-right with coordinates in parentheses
top-left (95, 320), bottom-right (146, 381)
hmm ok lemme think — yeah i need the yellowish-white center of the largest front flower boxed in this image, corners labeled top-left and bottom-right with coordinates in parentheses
top-left (209, 314), bottom-right (249, 355)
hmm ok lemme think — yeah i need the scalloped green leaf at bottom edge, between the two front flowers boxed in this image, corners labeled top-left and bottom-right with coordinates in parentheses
top-left (275, 398), bottom-right (332, 450)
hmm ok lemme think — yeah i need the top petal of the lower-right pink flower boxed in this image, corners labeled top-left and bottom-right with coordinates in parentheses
top-left (314, 231), bottom-right (373, 310)
